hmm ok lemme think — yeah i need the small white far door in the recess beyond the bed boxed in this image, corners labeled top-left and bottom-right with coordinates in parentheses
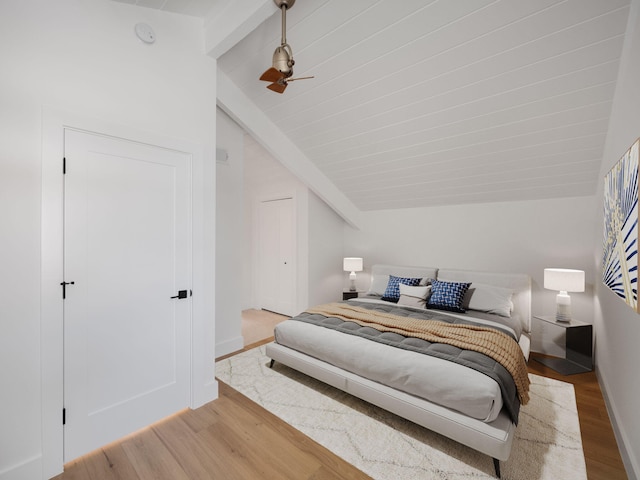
top-left (259, 198), bottom-right (297, 315)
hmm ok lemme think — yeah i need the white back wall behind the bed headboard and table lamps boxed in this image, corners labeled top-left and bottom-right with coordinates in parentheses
top-left (345, 197), bottom-right (596, 355)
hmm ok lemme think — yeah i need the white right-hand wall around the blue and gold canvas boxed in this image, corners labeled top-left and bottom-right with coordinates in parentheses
top-left (592, 0), bottom-right (640, 479)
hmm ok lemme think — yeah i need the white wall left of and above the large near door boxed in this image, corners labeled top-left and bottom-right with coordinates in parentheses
top-left (0, 0), bottom-right (216, 480)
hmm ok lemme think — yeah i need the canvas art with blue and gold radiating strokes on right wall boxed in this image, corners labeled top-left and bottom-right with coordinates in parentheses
top-left (602, 139), bottom-right (640, 312)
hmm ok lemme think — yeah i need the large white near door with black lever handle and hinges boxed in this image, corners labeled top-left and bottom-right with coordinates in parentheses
top-left (64, 129), bottom-right (191, 462)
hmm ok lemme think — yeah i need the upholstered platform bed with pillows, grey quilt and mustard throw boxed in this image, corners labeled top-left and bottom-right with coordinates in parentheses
top-left (266, 265), bottom-right (531, 478)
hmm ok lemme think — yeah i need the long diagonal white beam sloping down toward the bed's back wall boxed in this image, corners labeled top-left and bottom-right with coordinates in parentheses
top-left (217, 69), bottom-right (360, 228)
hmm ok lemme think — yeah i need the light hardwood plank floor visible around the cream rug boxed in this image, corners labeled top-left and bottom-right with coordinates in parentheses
top-left (55, 311), bottom-right (627, 480)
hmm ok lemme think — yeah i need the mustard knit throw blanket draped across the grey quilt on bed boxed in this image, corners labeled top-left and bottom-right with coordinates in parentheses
top-left (307, 303), bottom-right (529, 405)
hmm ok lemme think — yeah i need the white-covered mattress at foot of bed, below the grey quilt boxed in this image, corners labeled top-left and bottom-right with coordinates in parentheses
top-left (275, 320), bottom-right (502, 422)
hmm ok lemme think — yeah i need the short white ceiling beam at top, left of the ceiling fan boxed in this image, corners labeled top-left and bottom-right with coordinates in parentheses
top-left (204, 0), bottom-right (278, 59)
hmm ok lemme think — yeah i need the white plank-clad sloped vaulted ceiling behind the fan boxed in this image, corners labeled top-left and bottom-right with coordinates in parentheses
top-left (111, 0), bottom-right (629, 210)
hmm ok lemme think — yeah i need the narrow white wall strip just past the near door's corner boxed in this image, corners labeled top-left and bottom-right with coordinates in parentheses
top-left (216, 109), bottom-right (244, 356)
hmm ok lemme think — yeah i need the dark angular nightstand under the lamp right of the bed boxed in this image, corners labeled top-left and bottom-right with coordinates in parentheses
top-left (533, 315), bottom-right (593, 375)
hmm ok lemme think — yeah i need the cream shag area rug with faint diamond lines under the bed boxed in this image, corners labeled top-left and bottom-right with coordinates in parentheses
top-left (216, 346), bottom-right (587, 480)
